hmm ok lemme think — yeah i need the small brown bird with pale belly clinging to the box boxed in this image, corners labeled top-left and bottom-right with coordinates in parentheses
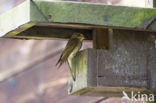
top-left (56, 33), bottom-right (85, 81)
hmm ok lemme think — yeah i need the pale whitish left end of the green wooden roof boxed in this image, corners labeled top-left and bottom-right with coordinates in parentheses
top-left (0, 0), bottom-right (47, 36)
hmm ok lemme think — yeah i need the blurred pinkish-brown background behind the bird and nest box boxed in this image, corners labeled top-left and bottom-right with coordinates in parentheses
top-left (0, 0), bottom-right (148, 103)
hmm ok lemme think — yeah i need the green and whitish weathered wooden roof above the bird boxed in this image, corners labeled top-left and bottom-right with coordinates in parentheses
top-left (0, 0), bottom-right (156, 40)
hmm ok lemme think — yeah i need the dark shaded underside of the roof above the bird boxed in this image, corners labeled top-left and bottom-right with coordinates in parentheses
top-left (17, 26), bottom-right (92, 40)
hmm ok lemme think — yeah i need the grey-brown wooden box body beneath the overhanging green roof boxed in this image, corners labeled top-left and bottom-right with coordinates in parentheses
top-left (70, 30), bottom-right (156, 97)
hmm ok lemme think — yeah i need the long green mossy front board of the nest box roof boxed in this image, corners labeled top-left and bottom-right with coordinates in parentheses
top-left (35, 1), bottom-right (156, 28)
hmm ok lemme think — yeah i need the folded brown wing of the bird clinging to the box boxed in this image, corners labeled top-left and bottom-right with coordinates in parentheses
top-left (61, 38), bottom-right (80, 61)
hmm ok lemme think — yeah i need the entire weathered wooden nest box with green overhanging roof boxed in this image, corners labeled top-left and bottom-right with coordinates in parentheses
top-left (0, 0), bottom-right (156, 97)
